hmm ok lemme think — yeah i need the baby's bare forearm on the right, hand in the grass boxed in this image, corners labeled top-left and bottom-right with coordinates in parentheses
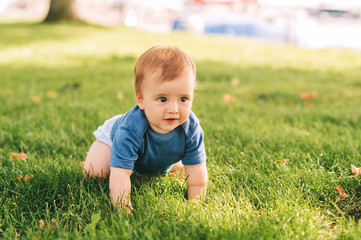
top-left (184, 162), bottom-right (208, 200)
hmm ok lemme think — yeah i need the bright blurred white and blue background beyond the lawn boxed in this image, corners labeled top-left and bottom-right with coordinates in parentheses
top-left (0, 0), bottom-right (361, 50)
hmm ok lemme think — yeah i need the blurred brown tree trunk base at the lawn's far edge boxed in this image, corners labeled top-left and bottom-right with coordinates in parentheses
top-left (44, 0), bottom-right (78, 22)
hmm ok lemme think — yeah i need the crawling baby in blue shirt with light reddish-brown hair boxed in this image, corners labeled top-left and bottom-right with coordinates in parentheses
top-left (84, 46), bottom-right (208, 209)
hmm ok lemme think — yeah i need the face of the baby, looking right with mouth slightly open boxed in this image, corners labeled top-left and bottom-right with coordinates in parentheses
top-left (136, 69), bottom-right (195, 133)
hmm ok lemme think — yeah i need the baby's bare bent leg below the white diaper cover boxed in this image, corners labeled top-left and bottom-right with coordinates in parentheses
top-left (83, 140), bottom-right (111, 178)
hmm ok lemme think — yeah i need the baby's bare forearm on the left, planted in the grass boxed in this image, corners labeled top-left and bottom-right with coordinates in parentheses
top-left (109, 167), bottom-right (132, 212)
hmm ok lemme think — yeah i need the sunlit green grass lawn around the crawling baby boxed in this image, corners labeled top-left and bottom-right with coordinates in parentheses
top-left (0, 24), bottom-right (361, 239)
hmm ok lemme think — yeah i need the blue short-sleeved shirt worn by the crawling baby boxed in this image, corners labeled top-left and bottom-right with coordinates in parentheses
top-left (110, 105), bottom-right (206, 175)
